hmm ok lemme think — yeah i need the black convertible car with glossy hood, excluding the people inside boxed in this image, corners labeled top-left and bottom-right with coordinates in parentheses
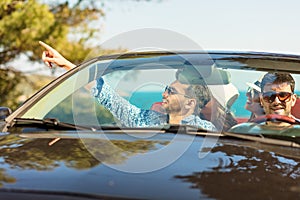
top-left (0, 51), bottom-right (300, 199)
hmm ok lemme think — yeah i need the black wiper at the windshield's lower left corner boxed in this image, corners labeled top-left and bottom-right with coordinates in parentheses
top-left (10, 118), bottom-right (94, 131)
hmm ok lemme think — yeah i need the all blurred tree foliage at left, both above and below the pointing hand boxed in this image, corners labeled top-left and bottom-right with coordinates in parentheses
top-left (0, 0), bottom-right (162, 109)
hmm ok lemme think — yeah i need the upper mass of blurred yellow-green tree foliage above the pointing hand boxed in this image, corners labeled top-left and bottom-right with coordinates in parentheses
top-left (0, 0), bottom-right (104, 64)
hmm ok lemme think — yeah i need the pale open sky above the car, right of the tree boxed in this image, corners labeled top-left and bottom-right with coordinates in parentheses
top-left (14, 0), bottom-right (300, 74)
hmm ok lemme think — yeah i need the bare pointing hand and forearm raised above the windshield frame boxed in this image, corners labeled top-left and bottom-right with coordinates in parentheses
top-left (39, 41), bottom-right (76, 70)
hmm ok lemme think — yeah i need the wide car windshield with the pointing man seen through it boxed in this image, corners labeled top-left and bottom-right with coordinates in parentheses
top-left (8, 53), bottom-right (300, 138)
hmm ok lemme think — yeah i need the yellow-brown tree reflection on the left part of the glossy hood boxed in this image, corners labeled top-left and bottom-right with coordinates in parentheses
top-left (0, 133), bottom-right (168, 171)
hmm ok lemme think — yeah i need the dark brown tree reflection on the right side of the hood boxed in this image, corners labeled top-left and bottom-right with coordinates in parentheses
top-left (174, 145), bottom-right (300, 199)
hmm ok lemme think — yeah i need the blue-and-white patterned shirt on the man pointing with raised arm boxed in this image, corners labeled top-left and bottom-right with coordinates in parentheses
top-left (92, 78), bottom-right (216, 131)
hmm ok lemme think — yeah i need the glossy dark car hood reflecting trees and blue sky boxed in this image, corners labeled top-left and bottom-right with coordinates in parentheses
top-left (0, 132), bottom-right (300, 199)
